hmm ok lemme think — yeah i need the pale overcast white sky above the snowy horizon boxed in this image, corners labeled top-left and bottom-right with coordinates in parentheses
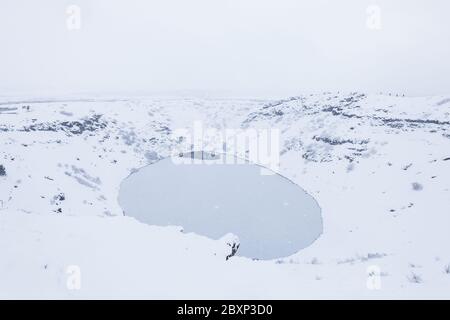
top-left (0, 0), bottom-right (450, 96)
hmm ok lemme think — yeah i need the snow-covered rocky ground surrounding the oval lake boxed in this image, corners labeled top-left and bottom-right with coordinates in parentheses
top-left (0, 93), bottom-right (450, 299)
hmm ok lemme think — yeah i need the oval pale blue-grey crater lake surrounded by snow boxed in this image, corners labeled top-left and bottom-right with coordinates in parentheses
top-left (119, 152), bottom-right (322, 259)
